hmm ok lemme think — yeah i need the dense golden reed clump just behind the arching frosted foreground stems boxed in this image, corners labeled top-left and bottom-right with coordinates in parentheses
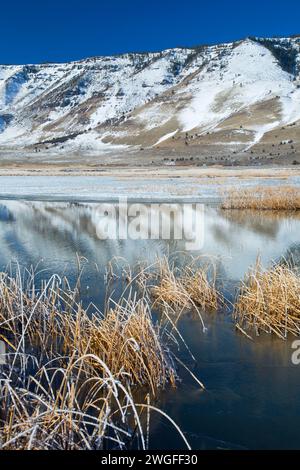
top-left (58, 300), bottom-right (176, 395)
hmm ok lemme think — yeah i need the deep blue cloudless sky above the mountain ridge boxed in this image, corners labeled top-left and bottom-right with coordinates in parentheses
top-left (0, 0), bottom-right (300, 64)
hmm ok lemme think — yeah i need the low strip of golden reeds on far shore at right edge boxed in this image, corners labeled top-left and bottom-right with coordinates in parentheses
top-left (221, 186), bottom-right (300, 211)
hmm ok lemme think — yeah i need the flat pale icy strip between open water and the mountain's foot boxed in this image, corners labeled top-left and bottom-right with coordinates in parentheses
top-left (0, 166), bottom-right (300, 204)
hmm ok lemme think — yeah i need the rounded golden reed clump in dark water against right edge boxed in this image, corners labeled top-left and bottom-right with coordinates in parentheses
top-left (234, 261), bottom-right (300, 339)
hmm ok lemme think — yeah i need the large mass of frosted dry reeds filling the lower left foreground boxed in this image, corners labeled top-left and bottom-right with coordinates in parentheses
top-left (0, 268), bottom-right (188, 449)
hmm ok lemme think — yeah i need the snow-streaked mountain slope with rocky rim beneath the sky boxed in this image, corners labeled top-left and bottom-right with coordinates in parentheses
top-left (0, 37), bottom-right (300, 152)
